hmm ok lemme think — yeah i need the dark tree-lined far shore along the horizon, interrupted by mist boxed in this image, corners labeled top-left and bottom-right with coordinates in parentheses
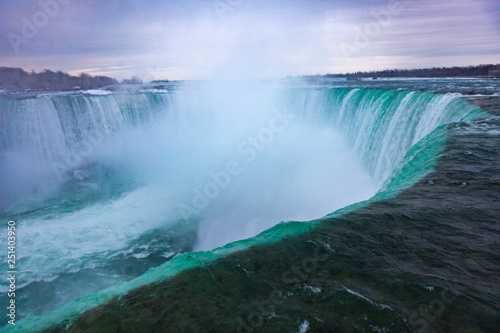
top-left (0, 64), bottom-right (500, 92)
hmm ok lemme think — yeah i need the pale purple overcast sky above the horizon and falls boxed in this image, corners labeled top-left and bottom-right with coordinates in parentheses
top-left (0, 0), bottom-right (500, 81)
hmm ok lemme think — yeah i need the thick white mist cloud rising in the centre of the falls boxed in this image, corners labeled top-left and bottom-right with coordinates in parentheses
top-left (89, 81), bottom-right (379, 250)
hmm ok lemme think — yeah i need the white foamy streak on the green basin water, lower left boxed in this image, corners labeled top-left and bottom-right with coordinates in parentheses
top-left (1, 186), bottom-right (179, 292)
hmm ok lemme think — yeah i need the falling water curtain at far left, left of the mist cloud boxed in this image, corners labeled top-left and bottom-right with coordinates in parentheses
top-left (0, 93), bottom-right (170, 206)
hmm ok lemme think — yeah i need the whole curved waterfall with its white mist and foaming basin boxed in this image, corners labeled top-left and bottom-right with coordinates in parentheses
top-left (0, 84), bottom-right (484, 322)
